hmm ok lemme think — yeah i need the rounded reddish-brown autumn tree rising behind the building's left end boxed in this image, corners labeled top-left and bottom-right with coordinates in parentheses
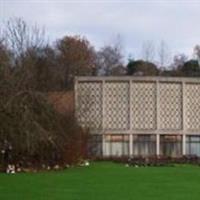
top-left (56, 36), bottom-right (96, 88)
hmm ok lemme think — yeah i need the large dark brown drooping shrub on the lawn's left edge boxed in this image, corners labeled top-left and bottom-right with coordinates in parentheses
top-left (0, 91), bottom-right (87, 170)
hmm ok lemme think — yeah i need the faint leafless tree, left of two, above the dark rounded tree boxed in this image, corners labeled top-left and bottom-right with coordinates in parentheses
top-left (142, 40), bottom-right (155, 62)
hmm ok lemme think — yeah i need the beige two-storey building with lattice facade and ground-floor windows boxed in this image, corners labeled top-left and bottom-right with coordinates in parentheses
top-left (75, 76), bottom-right (200, 157)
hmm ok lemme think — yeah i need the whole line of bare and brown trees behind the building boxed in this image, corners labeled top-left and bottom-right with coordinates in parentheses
top-left (0, 18), bottom-right (200, 92)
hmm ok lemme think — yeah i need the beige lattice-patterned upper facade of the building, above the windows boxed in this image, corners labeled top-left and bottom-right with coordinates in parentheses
top-left (75, 77), bottom-right (200, 134)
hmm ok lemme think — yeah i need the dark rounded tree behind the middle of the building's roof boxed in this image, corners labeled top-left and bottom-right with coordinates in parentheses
top-left (127, 60), bottom-right (159, 76)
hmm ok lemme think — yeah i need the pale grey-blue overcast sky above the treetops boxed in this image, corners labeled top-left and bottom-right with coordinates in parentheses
top-left (0, 0), bottom-right (200, 61)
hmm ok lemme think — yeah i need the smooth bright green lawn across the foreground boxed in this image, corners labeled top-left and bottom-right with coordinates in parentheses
top-left (0, 162), bottom-right (200, 200)
